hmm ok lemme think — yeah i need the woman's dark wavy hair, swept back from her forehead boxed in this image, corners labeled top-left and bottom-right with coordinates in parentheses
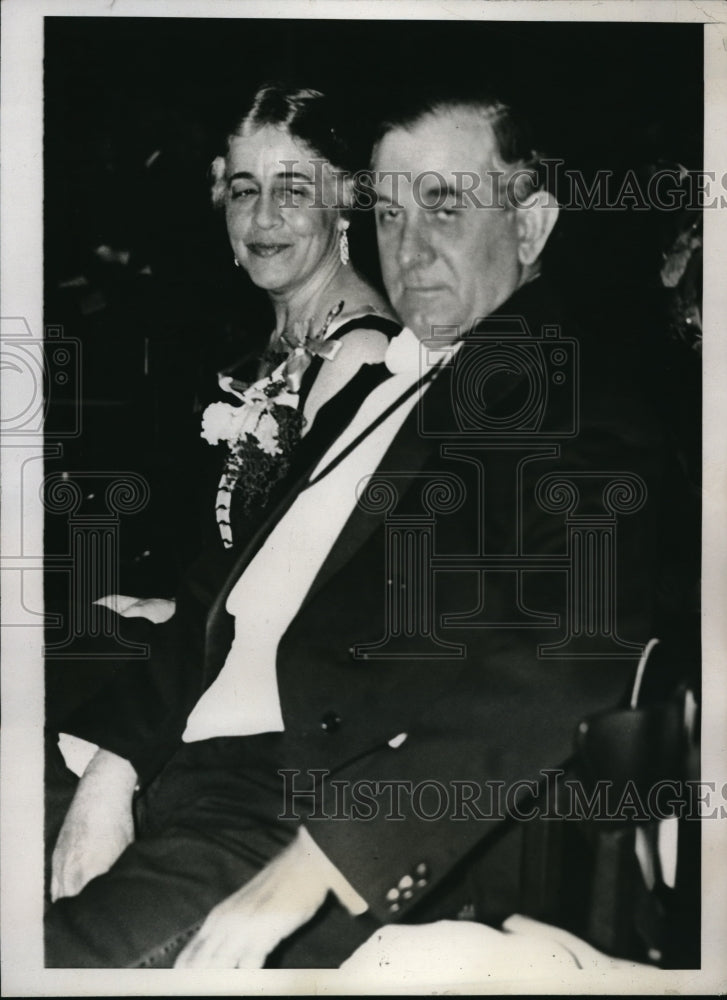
top-left (211, 82), bottom-right (360, 206)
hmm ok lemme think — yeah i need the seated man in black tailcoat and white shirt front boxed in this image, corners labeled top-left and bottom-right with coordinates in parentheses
top-left (46, 92), bottom-right (672, 967)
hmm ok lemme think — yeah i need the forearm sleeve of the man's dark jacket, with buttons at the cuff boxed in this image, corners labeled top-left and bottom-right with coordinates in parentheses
top-left (306, 648), bottom-right (633, 921)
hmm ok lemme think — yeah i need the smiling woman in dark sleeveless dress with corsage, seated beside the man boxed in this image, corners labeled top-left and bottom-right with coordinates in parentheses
top-left (46, 85), bottom-right (401, 876)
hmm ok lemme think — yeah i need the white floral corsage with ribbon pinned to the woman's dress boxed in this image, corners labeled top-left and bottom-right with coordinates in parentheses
top-left (201, 302), bottom-right (343, 548)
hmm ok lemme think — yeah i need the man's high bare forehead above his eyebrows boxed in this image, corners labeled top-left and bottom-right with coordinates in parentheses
top-left (373, 108), bottom-right (498, 177)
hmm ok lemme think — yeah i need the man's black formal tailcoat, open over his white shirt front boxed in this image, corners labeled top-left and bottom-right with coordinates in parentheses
top-left (68, 280), bottom-right (665, 920)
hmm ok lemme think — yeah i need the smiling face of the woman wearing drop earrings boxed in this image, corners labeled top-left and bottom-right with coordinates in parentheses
top-left (225, 125), bottom-right (340, 295)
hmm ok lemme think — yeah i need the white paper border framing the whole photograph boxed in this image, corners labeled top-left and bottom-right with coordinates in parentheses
top-left (0, 0), bottom-right (727, 996)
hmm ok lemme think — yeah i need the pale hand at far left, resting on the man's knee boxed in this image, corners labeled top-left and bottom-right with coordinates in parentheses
top-left (50, 750), bottom-right (136, 902)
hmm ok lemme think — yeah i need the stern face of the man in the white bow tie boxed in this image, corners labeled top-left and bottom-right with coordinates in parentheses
top-left (373, 109), bottom-right (521, 340)
